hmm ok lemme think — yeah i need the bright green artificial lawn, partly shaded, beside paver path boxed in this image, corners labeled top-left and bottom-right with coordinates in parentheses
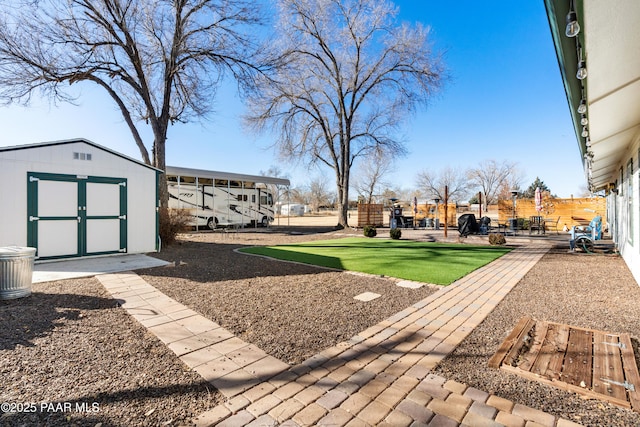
top-left (241, 237), bottom-right (511, 285)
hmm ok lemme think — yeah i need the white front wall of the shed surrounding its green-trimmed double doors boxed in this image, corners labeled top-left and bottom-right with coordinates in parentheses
top-left (0, 140), bottom-right (157, 260)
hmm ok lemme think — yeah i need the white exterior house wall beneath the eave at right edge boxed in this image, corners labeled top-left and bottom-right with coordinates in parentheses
top-left (607, 141), bottom-right (640, 284)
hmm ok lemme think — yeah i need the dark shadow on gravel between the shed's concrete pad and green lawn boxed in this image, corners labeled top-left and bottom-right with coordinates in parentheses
top-left (136, 241), bottom-right (326, 283)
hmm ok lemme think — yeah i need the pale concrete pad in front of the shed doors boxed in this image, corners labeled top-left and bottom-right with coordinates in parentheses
top-left (32, 254), bottom-right (169, 283)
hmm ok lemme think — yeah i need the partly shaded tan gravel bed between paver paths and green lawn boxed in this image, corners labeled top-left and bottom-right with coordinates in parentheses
top-left (139, 232), bottom-right (437, 364)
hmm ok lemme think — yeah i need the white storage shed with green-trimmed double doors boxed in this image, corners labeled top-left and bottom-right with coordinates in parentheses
top-left (0, 139), bottom-right (162, 259)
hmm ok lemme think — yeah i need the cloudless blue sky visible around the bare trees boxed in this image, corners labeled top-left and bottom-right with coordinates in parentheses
top-left (0, 0), bottom-right (584, 198)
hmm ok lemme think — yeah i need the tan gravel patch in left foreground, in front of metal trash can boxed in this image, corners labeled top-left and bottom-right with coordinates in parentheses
top-left (0, 278), bottom-right (222, 427)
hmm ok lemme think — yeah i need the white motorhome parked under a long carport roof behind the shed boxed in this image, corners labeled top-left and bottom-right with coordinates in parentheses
top-left (167, 166), bottom-right (289, 230)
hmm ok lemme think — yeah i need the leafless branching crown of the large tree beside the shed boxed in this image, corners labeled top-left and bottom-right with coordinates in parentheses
top-left (0, 0), bottom-right (259, 212)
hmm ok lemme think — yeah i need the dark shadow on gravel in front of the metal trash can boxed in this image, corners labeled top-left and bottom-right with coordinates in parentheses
top-left (0, 292), bottom-right (117, 350)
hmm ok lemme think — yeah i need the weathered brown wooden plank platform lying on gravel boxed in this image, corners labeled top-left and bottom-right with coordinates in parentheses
top-left (489, 316), bottom-right (640, 412)
